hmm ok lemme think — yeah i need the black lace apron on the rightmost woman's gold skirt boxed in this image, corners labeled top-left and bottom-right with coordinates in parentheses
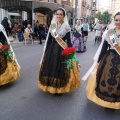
top-left (96, 50), bottom-right (120, 102)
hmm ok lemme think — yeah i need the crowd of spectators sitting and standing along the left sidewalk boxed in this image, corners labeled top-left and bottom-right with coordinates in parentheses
top-left (1, 17), bottom-right (48, 44)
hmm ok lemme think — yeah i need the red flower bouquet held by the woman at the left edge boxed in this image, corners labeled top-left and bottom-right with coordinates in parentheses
top-left (0, 44), bottom-right (13, 62)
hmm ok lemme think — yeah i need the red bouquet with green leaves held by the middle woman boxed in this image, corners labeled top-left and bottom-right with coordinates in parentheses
top-left (61, 47), bottom-right (78, 70)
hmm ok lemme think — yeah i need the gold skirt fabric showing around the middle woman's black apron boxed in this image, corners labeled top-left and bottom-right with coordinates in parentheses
top-left (38, 61), bottom-right (80, 94)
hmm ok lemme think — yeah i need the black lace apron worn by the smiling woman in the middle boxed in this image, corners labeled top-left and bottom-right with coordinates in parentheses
top-left (39, 42), bottom-right (69, 88)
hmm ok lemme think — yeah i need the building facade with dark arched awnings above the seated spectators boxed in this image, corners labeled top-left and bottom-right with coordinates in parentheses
top-left (0, 0), bottom-right (74, 24)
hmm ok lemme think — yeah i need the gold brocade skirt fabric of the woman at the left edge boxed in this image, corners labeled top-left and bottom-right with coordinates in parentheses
top-left (0, 61), bottom-right (20, 86)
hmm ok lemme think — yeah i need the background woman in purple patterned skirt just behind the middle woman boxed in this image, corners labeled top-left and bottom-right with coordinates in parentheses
top-left (72, 20), bottom-right (84, 52)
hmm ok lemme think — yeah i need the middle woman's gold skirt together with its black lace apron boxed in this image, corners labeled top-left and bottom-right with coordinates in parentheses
top-left (38, 42), bottom-right (80, 94)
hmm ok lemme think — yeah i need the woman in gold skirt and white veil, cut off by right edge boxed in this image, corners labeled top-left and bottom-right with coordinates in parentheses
top-left (83, 12), bottom-right (120, 109)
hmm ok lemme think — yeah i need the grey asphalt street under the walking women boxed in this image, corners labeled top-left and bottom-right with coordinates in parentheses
top-left (0, 32), bottom-right (120, 120)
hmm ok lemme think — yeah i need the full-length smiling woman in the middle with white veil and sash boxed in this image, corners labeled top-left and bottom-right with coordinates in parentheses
top-left (38, 8), bottom-right (80, 94)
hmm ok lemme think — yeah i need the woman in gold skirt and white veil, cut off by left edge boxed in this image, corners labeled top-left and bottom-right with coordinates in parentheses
top-left (0, 24), bottom-right (20, 86)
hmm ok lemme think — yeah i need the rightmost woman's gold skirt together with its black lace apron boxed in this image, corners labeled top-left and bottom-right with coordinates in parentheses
top-left (86, 50), bottom-right (120, 109)
